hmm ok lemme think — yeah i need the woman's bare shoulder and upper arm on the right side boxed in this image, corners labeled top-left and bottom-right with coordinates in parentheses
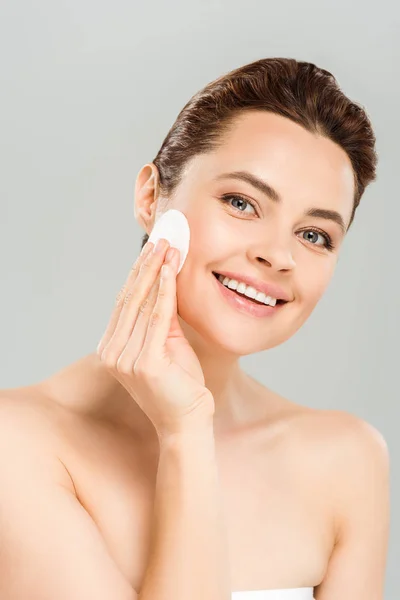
top-left (292, 410), bottom-right (390, 600)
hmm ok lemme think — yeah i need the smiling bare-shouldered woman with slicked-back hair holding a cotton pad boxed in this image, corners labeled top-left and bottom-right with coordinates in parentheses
top-left (0, 58), bottom-right (389, 600)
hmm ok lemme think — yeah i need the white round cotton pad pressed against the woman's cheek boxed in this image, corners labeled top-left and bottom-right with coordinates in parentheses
top-left (148, 208), bottom-right (190, 274)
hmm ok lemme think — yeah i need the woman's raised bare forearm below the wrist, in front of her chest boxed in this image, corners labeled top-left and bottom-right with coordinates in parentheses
top-left (139, 422), bottom-right (231, 600)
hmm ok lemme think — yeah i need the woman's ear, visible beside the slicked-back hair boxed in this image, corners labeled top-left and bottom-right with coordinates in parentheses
top-left (134, 163), bottom-right (159, 235)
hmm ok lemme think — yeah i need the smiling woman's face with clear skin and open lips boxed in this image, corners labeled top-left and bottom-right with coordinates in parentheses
top-left (150, 112), bottom-right (354, 356)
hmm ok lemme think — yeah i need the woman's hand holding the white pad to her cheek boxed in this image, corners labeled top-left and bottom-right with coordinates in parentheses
top-left (97, 240), bottom-right (215, 436)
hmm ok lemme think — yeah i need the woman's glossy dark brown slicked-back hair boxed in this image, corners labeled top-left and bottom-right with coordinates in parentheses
top-left (142, 58), bottom-right (377, 248)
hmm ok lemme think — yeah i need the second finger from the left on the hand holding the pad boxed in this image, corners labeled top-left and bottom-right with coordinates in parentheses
top-left (102, 243), bottom-right (169, 362)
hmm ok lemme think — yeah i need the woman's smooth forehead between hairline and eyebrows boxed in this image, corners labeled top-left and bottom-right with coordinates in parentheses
top-left (187, 111), bottom-right (354, 222)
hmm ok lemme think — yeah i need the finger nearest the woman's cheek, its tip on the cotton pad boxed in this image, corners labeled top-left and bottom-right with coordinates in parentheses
top-left (139, 248), bottom-right (179, 358)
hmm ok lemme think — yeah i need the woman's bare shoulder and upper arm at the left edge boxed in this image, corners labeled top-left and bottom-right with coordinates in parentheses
top-left (0, 387), bottom-right (137, 600)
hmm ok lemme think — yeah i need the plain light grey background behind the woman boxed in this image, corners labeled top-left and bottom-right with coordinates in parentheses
top-left (0, 0), bottom-right (400, 600)
